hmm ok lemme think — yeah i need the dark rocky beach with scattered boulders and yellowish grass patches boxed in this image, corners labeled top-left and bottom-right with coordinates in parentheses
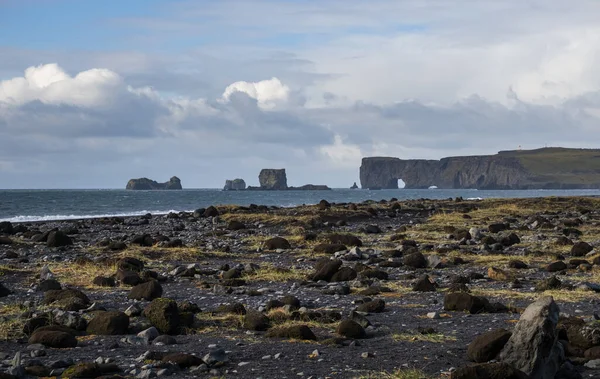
top-left (0, 198), bottom-right (600, 378)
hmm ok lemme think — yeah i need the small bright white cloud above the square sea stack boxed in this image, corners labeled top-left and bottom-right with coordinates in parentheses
top-left (223, 78), bottom-right (290, 109)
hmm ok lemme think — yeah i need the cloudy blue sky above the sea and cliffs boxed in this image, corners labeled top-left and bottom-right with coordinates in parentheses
top-left (0, 0), bottom-right (600, 188)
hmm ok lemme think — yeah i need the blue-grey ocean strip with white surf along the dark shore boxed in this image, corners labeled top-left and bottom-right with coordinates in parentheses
top-left (0, 189), bottom-right (600, 222)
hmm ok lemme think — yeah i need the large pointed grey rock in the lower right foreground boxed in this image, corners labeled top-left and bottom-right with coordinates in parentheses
top-left (498, 296), bottom-right (564, 379)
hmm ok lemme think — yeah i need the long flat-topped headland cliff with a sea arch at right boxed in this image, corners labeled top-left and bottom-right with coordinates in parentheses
top-left (360, 148), bottom-right (600, 189)
